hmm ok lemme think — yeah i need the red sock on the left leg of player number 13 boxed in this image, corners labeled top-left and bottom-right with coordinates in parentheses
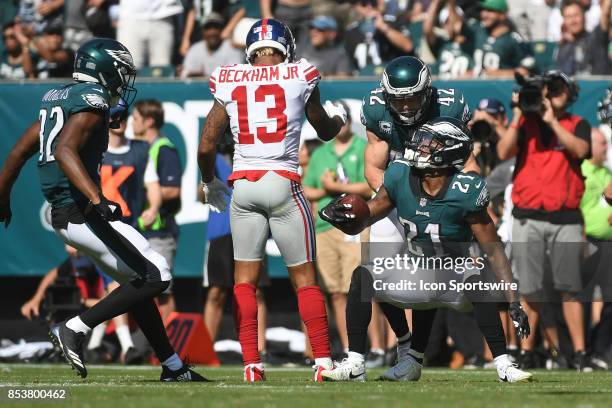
top-left (234, 283), bottom-right (261, 365)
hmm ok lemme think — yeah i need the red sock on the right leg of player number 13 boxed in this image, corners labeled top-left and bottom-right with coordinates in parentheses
top-left (297, 286), bottom-right (331, 358)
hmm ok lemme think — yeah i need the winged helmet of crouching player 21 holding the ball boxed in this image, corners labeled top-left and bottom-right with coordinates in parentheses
top-left (404, 116), bottom-right (474, 170)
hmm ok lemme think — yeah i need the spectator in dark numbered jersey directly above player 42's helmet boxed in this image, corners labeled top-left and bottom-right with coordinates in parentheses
top-left (344, 0), bottom-right (414, 74)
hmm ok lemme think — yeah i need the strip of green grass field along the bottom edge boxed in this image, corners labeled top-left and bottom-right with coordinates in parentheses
top-left (0, 364), bottom-right (612, 408)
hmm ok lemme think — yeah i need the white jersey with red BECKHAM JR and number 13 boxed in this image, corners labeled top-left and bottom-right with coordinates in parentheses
top-left (210, 59), bottom-right (321, 179)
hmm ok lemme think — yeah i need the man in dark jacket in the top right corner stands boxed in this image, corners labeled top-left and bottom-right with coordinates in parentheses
top-left (557, 0), bottom-right (612, 75)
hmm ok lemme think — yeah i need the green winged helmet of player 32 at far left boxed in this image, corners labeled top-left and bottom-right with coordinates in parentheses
top-left (72, 38), bottom-right (136, 106)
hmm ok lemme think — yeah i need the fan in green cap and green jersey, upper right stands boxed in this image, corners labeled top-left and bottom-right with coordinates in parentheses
top-left (462, 0), bottom-right (535, 78)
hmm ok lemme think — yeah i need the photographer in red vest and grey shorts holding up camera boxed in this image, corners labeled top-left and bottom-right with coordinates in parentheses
top-left (497, 71), bottom-right (591, 371)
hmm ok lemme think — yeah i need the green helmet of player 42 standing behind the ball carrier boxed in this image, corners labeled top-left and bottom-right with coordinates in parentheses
top-left (380, 56), bottom-right (432, 125)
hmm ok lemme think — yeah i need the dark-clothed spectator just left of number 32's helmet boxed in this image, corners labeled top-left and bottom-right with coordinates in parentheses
top-left (33, 25), bottom-right (74, 78)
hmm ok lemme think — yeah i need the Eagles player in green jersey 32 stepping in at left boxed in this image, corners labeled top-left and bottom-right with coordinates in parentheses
top-left (0, 38), bottom-right (206, 381)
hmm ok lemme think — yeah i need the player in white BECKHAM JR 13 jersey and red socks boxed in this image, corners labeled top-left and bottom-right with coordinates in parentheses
top-left (198, 19), bottom-right (346, 382)
